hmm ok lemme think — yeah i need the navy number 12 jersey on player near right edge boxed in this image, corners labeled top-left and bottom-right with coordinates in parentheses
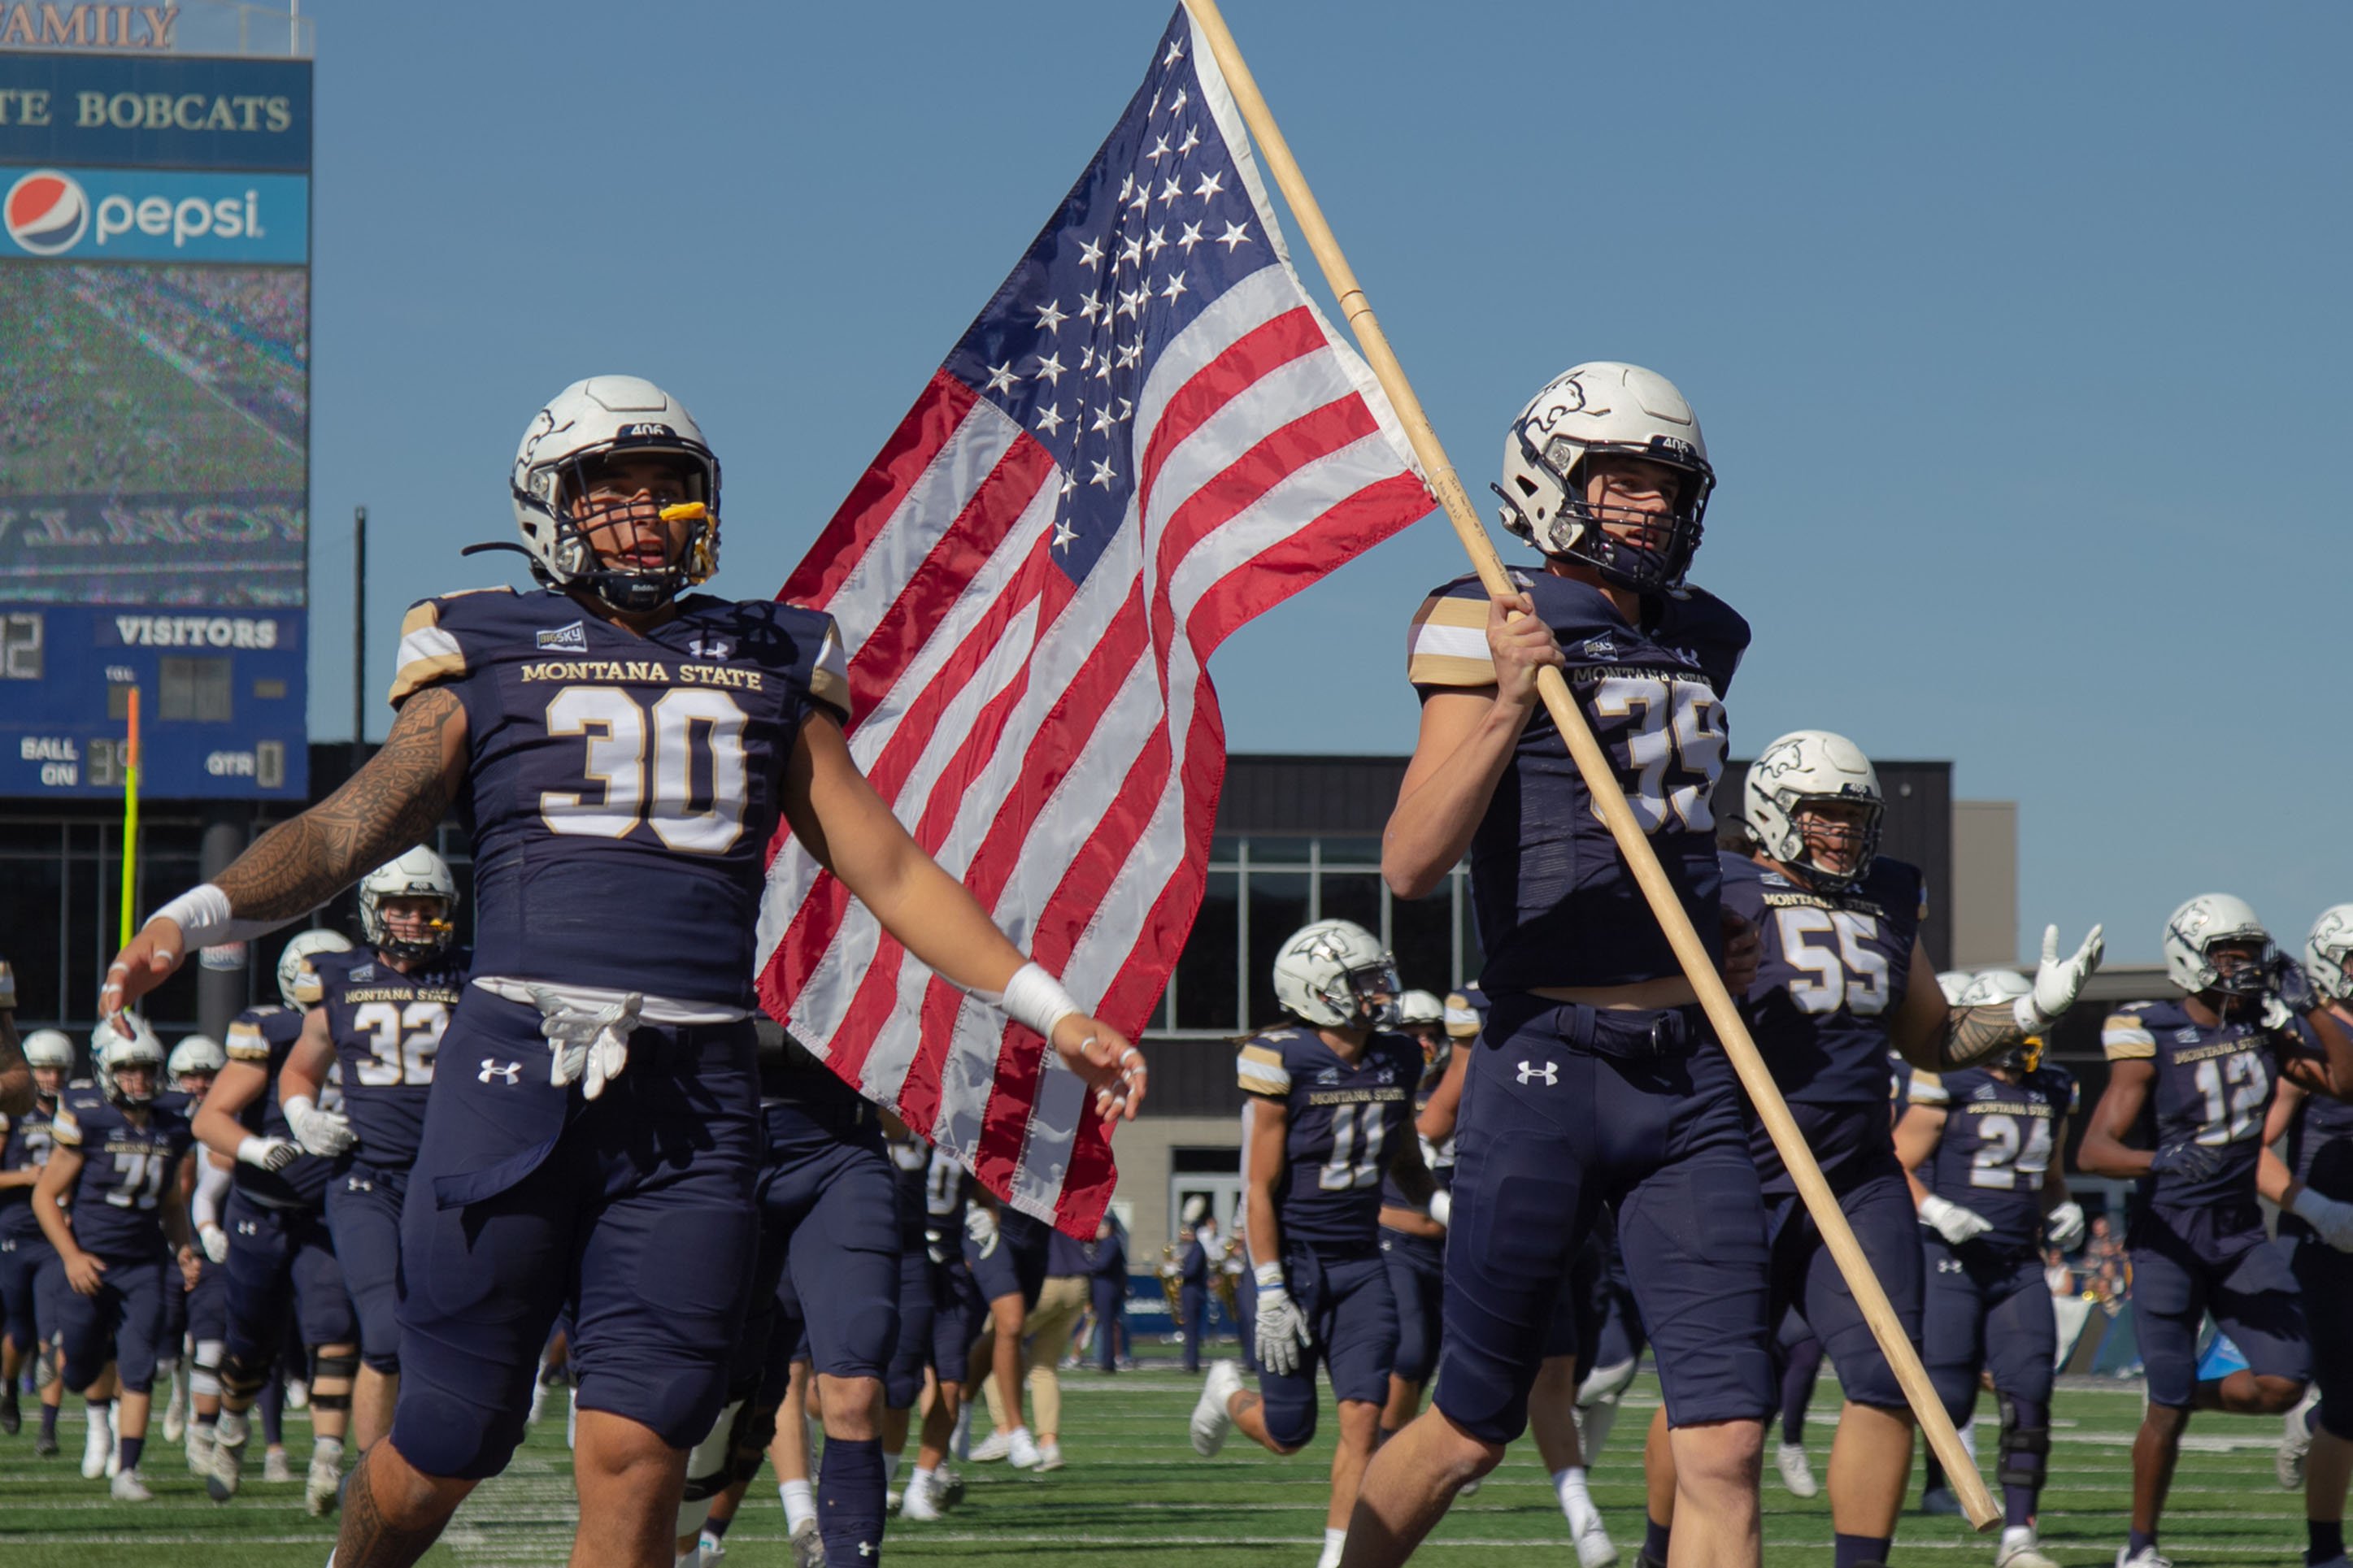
top-left (2099, 1001), bottom-right (2297, 1209)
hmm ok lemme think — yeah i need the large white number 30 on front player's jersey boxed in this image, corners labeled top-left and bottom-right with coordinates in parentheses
top-left (539, 686), bottom-right (746, 856)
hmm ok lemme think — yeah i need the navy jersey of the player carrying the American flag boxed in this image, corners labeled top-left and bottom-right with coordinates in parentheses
top-left (1407, 571), bottom-right (1748, 990)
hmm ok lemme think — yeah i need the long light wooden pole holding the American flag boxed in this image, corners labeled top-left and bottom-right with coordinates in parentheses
top-left (1184, 0), bottom-right (2000, 1531)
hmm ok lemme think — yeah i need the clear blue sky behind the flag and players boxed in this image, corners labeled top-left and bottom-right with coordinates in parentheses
top-left (285, 0), bottom-right (2353, 959)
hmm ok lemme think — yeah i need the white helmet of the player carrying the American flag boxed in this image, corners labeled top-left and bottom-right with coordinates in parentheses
top-left (1492, 359), bottom-right (1716, 593)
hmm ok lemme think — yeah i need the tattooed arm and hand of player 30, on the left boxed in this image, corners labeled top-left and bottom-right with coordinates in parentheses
top-left (99, 686), bottom-right (466, 1018)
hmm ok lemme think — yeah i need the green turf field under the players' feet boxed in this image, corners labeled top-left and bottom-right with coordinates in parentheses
top-left (0, 1370), bottom-right (2303, 1568)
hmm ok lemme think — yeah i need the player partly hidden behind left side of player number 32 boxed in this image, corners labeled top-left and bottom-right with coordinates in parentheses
top-left (195, 931), bottom-right (360, 1514)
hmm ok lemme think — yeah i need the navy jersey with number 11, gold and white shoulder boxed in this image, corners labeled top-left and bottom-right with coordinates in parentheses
top-left (1235, 1030), bottom-right (1421, 1251)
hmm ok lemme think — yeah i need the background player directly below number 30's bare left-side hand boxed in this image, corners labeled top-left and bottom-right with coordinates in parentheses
top-left (33, 1013), bottom-right (195, 1502)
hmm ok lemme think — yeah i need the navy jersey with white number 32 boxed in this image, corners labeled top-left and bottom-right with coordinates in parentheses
top-left (294, 947), bottom-right (471, 1171)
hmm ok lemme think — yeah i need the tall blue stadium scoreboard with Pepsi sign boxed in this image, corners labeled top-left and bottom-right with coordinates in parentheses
top-left (0, 50), bottom-right (311, 801)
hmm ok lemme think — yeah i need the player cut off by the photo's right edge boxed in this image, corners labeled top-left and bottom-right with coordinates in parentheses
top-left (2261, 903), bottom-right (2353, 1568)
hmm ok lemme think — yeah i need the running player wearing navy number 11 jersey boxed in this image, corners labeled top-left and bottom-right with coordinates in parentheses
top-left (1193, 919), bottom-right (1447, 1568)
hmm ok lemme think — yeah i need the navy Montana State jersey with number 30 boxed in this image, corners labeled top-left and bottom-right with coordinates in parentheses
top-left (393, 588), bottom-right (850, 1013)
